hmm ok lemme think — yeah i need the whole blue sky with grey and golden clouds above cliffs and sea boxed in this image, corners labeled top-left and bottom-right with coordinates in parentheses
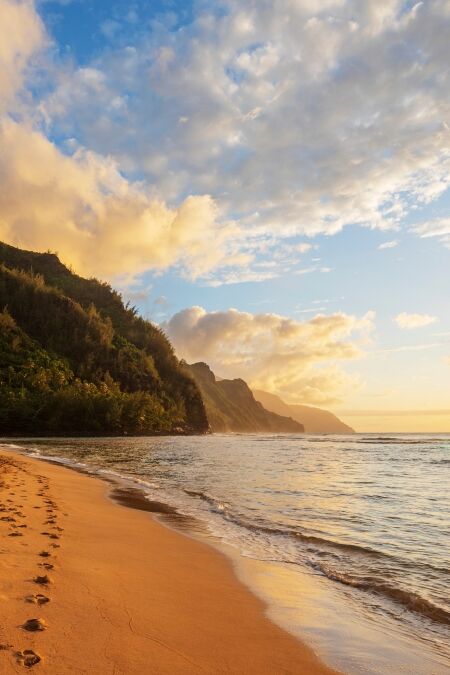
top-left (0, 0), bottom-right (450, 432)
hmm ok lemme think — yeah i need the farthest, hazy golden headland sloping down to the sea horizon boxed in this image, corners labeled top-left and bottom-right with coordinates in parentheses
top-left (253, 389), bottom-right (354, 434)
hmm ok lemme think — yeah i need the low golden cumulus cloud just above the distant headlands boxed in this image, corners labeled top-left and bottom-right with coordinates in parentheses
top-left (162, 307), bottom-right (374, 404)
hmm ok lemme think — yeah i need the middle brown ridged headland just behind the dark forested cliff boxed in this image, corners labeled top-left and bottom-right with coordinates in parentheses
top-left (186, 363), bottom-right (304, 433)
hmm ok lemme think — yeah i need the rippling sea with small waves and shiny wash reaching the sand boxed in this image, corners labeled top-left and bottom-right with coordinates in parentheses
top-left (0, 434), bottom-right (450, 675)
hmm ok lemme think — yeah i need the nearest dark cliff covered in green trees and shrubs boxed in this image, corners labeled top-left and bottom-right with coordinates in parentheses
top-left (0, 243), bottom-right (209, 435)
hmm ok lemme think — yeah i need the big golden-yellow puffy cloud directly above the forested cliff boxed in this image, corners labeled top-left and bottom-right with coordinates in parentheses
top-left (0, 120), bottom-right (239, 278)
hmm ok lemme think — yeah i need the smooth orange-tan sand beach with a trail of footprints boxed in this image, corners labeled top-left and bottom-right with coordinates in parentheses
top-left (0, 452), bottom-right (334, 675)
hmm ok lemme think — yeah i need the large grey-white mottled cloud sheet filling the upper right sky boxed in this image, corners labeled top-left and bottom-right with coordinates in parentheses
top-left (37, 0), bottom-right (450, 248)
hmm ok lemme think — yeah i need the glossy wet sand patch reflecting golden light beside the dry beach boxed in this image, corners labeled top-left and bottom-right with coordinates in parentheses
top-left (232, 558), bottom-right (447, 675)
